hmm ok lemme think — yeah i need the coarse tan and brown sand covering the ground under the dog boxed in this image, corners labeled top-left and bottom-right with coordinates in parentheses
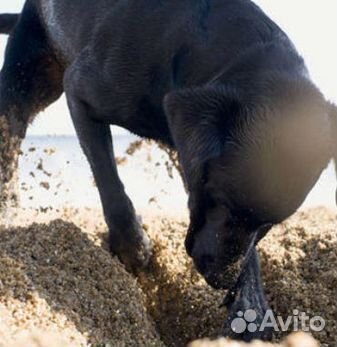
top-left (0, 209), bottom-right (337, 347)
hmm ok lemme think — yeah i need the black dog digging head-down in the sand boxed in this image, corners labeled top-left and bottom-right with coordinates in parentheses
top-left (0, 0), bottom-right (333, 340)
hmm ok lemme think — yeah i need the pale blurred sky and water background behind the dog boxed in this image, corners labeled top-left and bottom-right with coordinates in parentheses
top-left (0, 0), bottom-right (337, 214)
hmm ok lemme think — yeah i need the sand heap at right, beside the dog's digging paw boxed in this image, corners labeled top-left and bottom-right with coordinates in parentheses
top-left (260, 209), bottom-right (337, 347)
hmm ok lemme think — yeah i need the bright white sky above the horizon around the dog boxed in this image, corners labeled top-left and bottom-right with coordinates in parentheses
top-left (0, 0), bottom-right (337, 135)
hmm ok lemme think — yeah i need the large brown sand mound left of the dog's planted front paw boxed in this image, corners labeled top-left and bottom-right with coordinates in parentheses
top-left (0, 220), bottom-right (162, 347)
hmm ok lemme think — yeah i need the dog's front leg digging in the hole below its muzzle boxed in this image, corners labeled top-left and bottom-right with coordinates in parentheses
top-left (224, 249), bottom-right (272, 342)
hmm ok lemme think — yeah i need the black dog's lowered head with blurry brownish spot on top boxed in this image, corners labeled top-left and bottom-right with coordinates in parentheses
top-left (165, 79), bottom-right (331, 288)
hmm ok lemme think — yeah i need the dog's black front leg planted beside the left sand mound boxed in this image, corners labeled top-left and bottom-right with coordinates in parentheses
top-left (64, 68), bottom-right (151, 272)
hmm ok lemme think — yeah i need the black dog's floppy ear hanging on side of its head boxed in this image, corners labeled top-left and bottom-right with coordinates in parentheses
top-left (164, 86), bottom-right (241, 186)
